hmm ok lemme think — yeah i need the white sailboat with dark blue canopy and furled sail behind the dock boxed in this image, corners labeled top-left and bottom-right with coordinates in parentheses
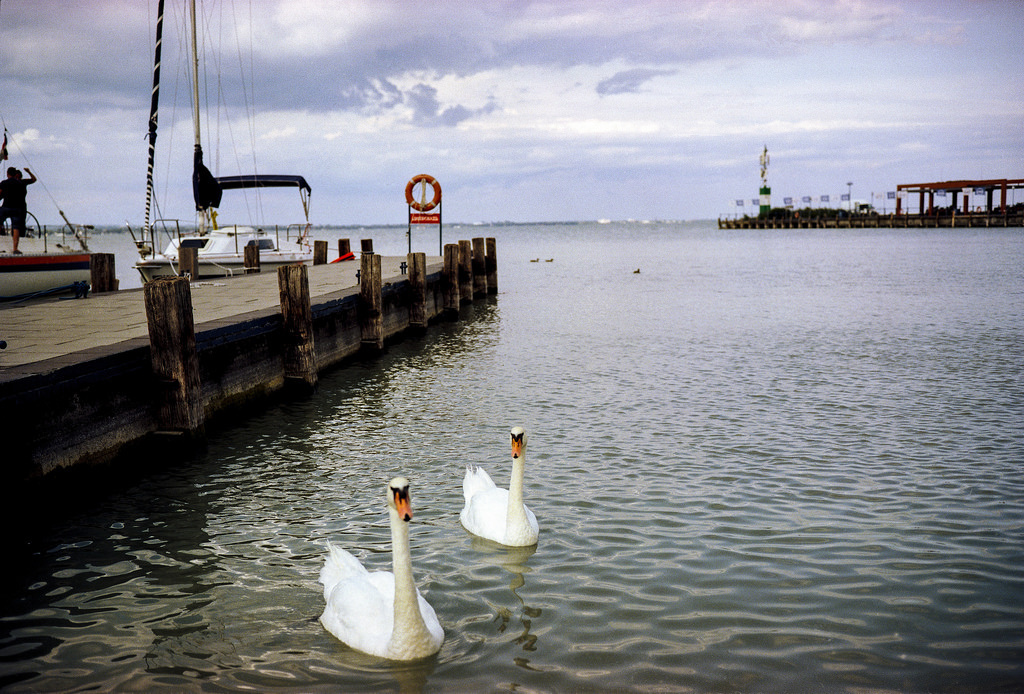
top-left (133, 0), bottom-right (312, 281)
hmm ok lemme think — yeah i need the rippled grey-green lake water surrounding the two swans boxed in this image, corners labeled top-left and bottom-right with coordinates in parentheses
top-left (0, 223), bottom-right (1024, 692)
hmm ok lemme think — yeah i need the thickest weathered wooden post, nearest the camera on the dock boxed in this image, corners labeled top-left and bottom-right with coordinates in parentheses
top-left (143, 274), bottom-right (205, 439)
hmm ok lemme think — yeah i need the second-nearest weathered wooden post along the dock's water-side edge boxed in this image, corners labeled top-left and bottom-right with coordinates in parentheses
top-left (278, 263), bottom-right (317, 391)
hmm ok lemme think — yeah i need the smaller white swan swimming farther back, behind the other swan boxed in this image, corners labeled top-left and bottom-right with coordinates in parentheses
top-left (459, 427), bottom-right (540, 547)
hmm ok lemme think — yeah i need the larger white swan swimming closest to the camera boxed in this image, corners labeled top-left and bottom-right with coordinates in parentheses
top-left (319, 477), bottom-right (444, 660)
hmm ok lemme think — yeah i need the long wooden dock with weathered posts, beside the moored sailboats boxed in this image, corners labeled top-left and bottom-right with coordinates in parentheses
top-left (0, 238), bottom-right (497, 488)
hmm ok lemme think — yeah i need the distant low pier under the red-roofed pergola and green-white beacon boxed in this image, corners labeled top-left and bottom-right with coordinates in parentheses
top-left (718, 210), bottom-right (1024, 229)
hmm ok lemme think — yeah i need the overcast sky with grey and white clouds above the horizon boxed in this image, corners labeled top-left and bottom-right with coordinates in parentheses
top-left (0, 0), bottom-right (1024, 226)
